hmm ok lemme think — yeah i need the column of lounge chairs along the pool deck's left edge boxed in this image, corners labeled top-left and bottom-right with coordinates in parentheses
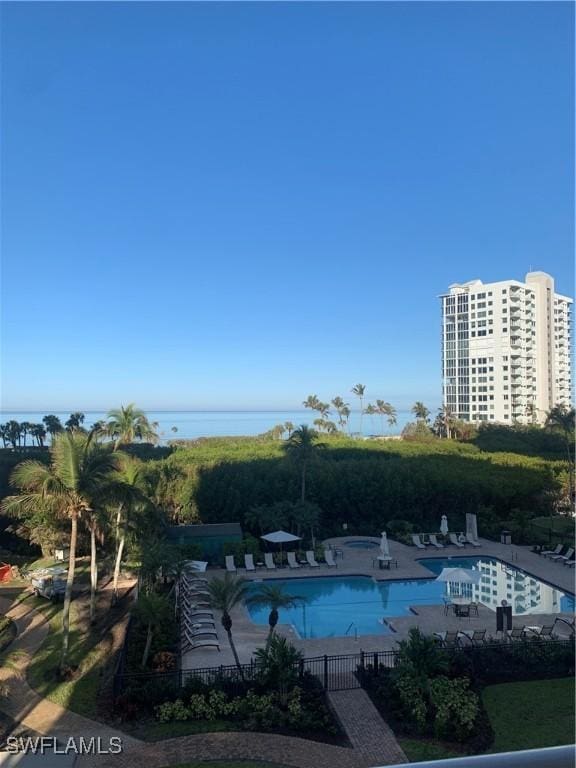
top-left (179, 574), bottom-right (220, 651)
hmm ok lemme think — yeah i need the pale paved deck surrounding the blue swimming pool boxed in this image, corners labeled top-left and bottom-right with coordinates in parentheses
top-left (182, 536), bottom-right (575, 669)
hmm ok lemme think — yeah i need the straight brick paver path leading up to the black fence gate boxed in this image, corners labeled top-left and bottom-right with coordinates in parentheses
top-left (328, 688), bottom-right (408, 765)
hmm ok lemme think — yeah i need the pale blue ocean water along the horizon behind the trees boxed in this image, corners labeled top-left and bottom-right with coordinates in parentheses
top-left (0, 409), bottom-right (413, 443)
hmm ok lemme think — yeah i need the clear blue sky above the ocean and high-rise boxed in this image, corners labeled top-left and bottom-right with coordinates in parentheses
top-left (1, 2), bottom-right (574, 409)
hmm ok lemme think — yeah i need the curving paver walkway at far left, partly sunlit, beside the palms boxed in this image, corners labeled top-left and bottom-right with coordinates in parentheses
top-left (0, 595), bottom-right (141, 746)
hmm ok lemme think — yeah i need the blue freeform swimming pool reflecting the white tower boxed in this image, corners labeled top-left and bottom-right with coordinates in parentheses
top-left (248, 557), bottom-right (574, 638)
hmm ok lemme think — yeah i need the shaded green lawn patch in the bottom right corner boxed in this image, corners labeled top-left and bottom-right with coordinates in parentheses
top-left (482, 678), bottom-right (574, 752)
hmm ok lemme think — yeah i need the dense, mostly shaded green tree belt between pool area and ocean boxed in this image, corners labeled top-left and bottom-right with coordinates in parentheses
top-left (146, 436), bottom-right (568, 535)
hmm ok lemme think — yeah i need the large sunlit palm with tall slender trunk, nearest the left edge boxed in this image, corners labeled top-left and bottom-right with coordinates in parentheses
top-left (1, 432), bottom-right (117, 674)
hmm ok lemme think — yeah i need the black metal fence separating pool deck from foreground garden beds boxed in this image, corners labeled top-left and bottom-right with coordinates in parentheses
top-left (114, 639), bottom-right (574, 697)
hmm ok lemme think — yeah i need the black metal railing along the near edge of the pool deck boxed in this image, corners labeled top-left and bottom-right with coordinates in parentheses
top-left (114, 638), bottom-right (574, 697)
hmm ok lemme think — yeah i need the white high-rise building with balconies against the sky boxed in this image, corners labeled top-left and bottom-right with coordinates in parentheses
top-left (440, 272), bottom-right (572, 424)
